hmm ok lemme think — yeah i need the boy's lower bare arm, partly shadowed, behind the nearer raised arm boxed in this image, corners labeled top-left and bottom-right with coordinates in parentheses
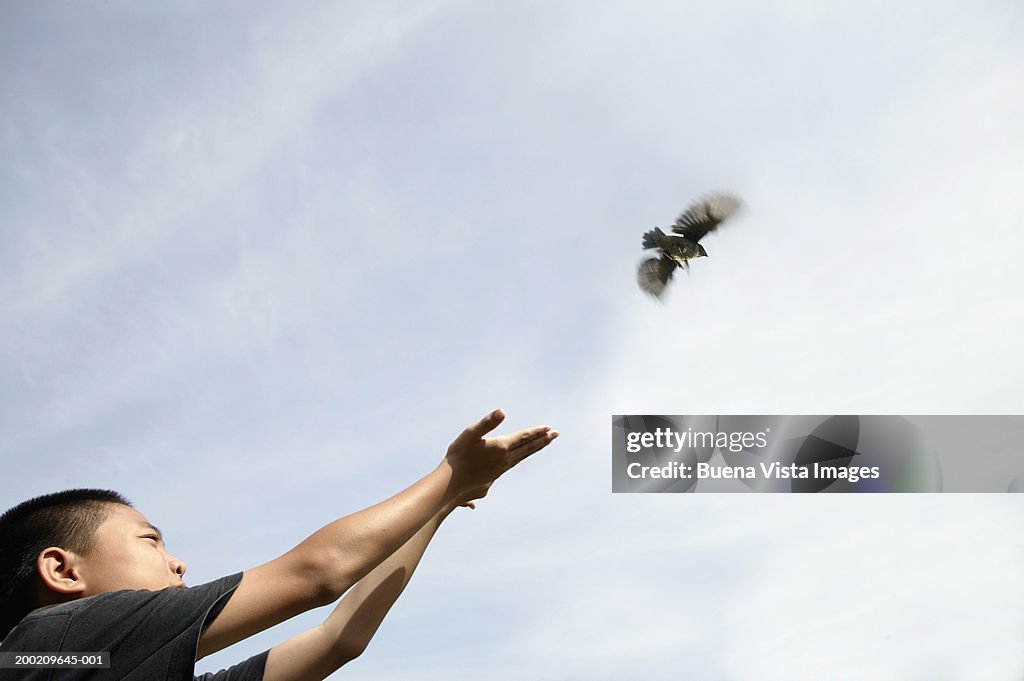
top-left (263, 499), bottom-right (460, 681)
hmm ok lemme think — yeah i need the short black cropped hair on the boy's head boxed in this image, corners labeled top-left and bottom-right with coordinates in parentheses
top-left (0, 490), bottom-right (131, 640)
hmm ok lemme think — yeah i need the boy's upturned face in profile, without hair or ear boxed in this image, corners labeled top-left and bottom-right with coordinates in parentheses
top-left (78, 504), bottom-right (185, 596)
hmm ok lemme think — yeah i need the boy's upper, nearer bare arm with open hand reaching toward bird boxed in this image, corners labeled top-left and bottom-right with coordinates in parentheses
top-left (197, 410), bottom-right (558, 658)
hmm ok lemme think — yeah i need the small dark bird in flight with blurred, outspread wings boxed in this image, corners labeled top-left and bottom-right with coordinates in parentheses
top-left (637, 194), bottom-right (741, 298)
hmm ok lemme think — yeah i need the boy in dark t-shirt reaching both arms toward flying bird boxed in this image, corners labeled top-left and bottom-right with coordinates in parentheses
top-left (0, 410), bottom-right (558, 681)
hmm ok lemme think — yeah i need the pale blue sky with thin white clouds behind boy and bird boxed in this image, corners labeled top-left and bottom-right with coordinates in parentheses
top-left (0, 0), bottom-right (1024, 681)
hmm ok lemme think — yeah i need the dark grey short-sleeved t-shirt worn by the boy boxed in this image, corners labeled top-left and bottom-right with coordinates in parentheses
top-left (0, 572), bottom-right (267, 681)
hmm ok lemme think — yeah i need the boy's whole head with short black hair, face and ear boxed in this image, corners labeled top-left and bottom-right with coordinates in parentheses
top-left (0, 490), bottom-right (185, 639)
